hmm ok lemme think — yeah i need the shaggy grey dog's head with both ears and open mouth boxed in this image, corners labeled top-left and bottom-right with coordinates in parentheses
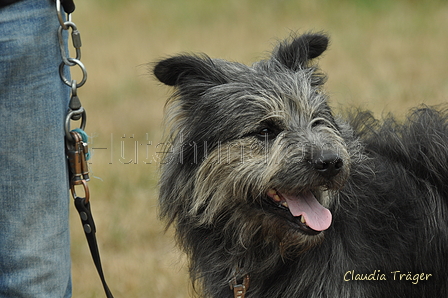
top-left (154, 34), bottom-right (353, 254)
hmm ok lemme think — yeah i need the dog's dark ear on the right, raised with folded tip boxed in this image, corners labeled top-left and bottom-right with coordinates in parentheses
top-left (273, 33), bottom-right (329, 71)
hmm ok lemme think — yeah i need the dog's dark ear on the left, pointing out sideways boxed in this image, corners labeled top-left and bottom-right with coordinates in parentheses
top-left (153, 55), bottom-right (226, 86)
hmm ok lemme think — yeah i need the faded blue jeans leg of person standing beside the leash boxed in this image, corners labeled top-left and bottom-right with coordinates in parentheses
top-left (0, 0), bottom-right (71, 298)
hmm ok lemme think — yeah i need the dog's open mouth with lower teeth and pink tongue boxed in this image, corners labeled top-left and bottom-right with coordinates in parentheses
top-left (267, 189), bottom-right (332, 235)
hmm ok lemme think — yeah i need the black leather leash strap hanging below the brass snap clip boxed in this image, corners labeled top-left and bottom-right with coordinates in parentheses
top-left (75, 197), bottom-right (114, 298)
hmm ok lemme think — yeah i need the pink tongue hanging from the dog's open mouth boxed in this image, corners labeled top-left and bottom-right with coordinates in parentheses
top-left (282, 191), bottom-right (331, 231)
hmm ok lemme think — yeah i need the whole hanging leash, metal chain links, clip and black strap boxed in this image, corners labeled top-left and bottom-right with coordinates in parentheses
top-left (56, 0), bottom-right (113, 298)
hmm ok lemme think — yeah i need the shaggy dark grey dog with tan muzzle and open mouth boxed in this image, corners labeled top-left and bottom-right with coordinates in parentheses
top-left (154, 33), bottom-right (448, 298)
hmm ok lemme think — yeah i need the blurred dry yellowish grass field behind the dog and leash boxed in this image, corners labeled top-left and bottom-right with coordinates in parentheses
top-left (71, 0), bottom-right (448, 298)
